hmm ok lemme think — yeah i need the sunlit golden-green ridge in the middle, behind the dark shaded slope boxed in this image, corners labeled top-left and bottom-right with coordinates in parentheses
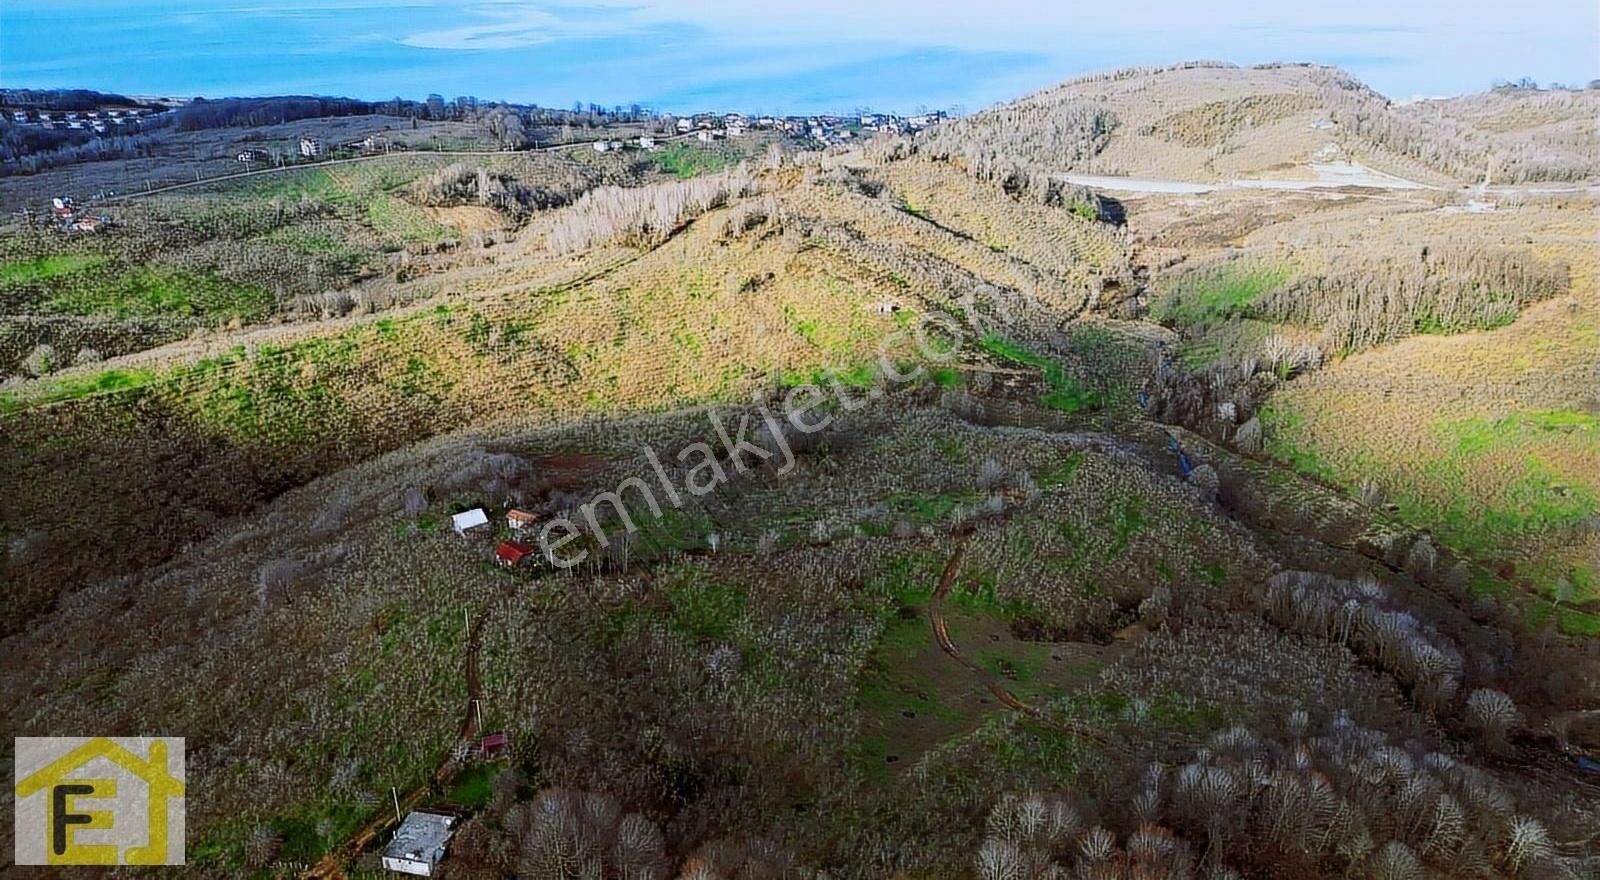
top-left (0, 152), bottom-right (1128, 626)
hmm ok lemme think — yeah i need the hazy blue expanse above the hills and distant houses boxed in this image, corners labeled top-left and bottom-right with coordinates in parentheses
top-left (0, 0), bottom-right (1600, 112)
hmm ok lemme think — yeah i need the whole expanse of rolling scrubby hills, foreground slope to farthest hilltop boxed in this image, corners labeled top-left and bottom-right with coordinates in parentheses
top-left (0, 66), bottom-right (1600, 880)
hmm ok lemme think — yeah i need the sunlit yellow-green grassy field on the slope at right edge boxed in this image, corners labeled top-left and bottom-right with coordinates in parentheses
top-left (1264, 208), bottom-right (1600, 632)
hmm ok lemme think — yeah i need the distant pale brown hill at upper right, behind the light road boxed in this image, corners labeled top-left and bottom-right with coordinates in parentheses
top-left (925, 62), bottom-right (1600, 186)
